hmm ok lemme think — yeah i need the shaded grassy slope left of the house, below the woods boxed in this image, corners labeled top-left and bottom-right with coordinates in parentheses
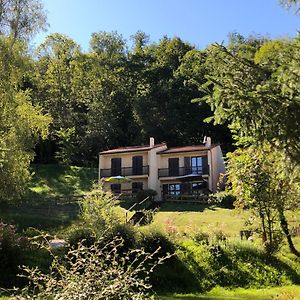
top-left (0, 165), bottom-right (97, 230)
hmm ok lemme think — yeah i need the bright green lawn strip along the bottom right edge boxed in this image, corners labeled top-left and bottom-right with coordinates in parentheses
top-left (158, 285), bottom-right (300, 300)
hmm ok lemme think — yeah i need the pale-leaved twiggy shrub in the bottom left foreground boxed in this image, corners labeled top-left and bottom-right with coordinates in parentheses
top-left (17, 239), bottom-right (168, 299)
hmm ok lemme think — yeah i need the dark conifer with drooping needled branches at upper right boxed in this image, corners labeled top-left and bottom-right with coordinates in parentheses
top-left (196, 39), bottom-right (300, 163)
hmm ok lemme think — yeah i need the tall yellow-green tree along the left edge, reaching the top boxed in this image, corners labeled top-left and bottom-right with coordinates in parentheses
top-left (0, 0), bottom-right (51, 201)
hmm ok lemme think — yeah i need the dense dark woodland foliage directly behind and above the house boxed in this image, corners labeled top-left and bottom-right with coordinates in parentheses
top-left (31, 32), bottom-right (229, 165)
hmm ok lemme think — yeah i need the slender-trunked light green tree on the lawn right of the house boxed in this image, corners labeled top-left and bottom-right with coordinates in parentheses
top-left (228, 144), bottom-right (300, 257)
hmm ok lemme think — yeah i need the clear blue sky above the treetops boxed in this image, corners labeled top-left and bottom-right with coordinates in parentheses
top-left (33, 0), bottom-right (300, 50)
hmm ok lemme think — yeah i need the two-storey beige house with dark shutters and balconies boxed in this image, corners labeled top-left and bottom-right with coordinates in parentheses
top-left (99, 138), bottom-right (225, 201)
